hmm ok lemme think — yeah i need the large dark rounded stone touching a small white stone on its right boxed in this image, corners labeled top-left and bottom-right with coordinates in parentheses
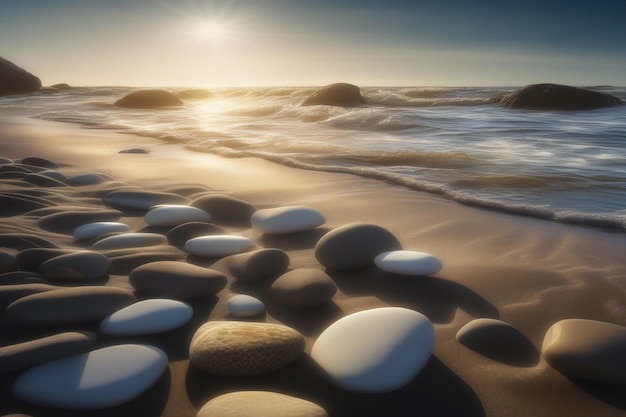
top-left (315, 223), bottom-right (402, 269)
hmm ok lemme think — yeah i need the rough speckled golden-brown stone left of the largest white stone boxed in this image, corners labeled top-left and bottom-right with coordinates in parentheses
top-left (189, 321), bottom-right (305, 376)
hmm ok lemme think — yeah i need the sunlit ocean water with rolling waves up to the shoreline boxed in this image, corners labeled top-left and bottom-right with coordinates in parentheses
top-left (0, 86), bottom-right (626, 232)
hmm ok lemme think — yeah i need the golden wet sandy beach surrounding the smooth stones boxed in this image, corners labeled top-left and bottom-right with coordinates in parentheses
top-left (0, 118), bottom-right (626, 417)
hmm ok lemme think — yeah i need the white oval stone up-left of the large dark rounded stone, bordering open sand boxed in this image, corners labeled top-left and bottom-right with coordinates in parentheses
top-left (250, 206), bottom-right (326, 234)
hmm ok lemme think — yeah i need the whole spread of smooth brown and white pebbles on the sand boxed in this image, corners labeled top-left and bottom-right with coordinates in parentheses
top-left (0, 154), bottom-right (626, 417)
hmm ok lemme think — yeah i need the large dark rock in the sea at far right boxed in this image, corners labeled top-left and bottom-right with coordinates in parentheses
top-left (499, 84), bottom-right (624, 110)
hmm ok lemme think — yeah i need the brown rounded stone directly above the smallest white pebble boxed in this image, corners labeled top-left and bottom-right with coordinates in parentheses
top-left (226, 248), bottom-right (289, 281)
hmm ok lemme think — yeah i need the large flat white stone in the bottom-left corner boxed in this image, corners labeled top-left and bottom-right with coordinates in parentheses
top-left (13, 345), bottom-right (168, 410)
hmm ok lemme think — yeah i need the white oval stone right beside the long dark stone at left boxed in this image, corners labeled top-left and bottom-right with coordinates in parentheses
top-left (100, 298), bottom-right (193, 336)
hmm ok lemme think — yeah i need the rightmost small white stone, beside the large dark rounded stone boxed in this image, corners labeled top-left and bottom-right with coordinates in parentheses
top-left (374, 250), bottom-right (443, 276)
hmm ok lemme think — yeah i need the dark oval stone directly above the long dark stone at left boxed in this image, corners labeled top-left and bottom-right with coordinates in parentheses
top-left (39, 250), bottom-right (112, 280)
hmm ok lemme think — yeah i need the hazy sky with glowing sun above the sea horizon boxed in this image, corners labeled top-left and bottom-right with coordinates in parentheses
top-left (0, 0), bottom-right (626, 87)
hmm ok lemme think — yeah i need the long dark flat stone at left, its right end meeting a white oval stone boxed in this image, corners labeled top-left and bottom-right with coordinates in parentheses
top-left (4, 286), bottom-right (137, 327)
